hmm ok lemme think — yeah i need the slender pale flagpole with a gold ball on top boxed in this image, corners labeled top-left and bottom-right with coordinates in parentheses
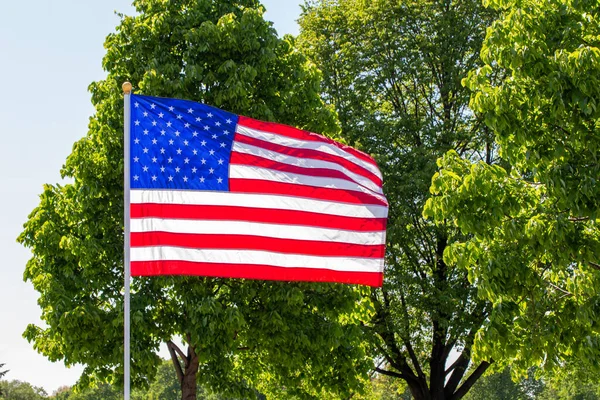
top-left (123, 82), bottom-right (132, 400)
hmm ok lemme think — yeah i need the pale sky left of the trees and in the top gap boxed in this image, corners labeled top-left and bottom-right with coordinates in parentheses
top-left (0, 0), bottom-right (303, 394)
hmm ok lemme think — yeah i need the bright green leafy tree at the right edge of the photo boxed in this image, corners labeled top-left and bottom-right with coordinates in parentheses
top-left (426, 0), bottom-right (600, 374)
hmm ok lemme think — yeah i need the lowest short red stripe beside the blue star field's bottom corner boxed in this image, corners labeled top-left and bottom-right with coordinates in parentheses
top-left (229, 178), bottom-right (388, 207)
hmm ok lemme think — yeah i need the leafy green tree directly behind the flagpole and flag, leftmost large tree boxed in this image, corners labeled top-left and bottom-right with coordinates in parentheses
top-left (18, 0), bottom-right (368, 399)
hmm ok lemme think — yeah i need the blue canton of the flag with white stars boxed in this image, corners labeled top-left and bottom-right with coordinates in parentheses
top-left (130, 95), bottom-right (238, 191)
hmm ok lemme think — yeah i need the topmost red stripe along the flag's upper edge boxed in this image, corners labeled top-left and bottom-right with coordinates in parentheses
top-left (238, 115), bottom-right (377, 166)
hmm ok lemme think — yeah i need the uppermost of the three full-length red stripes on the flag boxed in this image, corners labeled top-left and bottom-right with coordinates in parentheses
top-left (131, 203), bottom-right (386, 232)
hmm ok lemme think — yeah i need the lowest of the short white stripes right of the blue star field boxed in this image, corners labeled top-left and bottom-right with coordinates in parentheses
top-left (229, 164), bottom-right (387, 205)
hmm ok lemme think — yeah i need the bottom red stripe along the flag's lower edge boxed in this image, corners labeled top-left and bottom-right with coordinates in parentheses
top-left (131, 261), bottom-right (383, 287)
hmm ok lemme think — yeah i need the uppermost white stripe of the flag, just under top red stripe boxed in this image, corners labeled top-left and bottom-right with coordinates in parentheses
top-left (235, 124), bottom-right (382, 178)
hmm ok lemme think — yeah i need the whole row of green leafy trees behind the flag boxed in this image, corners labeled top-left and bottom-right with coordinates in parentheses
top-left (19, 0), bottom-right (600, 400)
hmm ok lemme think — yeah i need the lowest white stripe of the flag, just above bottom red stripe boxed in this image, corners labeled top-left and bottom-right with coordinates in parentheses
top-left (131, 246), bottom-right (383, 272)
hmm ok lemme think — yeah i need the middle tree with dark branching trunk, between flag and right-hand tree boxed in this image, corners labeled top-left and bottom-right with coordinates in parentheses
top-left (299, 0), bottom-right (496, 399)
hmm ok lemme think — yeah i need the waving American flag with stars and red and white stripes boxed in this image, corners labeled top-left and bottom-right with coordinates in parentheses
top-left (129, 95), bottom-right (388, 286)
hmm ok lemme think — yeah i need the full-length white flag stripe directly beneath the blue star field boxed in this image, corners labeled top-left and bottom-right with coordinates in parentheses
top-left (131, 189), bottom-right (388, 218)
